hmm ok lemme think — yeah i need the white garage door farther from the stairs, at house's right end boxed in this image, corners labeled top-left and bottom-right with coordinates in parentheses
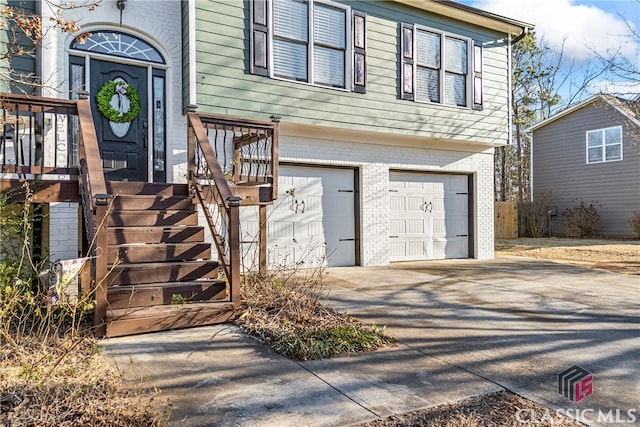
top-left (389, 172), bottom-right (469, 261)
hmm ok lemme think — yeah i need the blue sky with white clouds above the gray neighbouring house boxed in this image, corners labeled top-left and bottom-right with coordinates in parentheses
top-left (457, 0), bottom-right (640, 102)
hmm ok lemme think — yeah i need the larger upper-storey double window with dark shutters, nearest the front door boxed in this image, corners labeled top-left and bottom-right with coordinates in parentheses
top-left (250, 0), bottom-right (366, 92)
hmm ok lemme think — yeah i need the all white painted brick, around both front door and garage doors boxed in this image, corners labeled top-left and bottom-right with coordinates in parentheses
top-left (36, 0), bottom-right (493, 265)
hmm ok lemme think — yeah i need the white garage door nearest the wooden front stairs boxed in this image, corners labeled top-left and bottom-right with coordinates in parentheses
top-left (243, 166), bottom-right (356, 268)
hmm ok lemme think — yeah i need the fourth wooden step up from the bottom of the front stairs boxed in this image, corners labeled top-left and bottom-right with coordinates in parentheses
top-left (107, 243), bottom-right (211, 264)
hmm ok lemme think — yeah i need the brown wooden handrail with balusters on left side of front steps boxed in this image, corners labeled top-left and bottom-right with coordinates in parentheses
top-left (0, 93), bottom-right (109, 335)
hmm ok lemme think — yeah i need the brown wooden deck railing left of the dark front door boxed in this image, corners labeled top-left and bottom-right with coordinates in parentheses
top-left (0, 93), bottom-right (109, 332)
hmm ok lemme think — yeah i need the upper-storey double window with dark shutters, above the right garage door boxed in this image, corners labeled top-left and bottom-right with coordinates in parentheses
top-left (401, 24), bottom-right (483, 109)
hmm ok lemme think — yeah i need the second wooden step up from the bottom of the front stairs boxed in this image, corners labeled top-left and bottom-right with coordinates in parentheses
top-left (108, 279), bottom-right (227, 310)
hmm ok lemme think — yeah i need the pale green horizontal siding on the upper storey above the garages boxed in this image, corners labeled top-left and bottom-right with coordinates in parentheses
top-left (196, 0), bottom-right (507, 143)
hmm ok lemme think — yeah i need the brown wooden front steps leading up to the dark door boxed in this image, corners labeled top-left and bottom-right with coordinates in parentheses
top-left (105, 182), bottom-right (235, 337)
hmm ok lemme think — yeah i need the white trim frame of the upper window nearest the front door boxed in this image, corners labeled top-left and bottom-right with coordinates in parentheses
top-left (269, 0), bottom-right (353, 92)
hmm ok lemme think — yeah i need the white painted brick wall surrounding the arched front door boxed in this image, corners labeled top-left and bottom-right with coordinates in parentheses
top-left (41, 0), bottom-right (187, 261)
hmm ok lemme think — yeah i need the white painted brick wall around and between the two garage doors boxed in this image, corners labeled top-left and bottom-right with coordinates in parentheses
top-left (280, 135), bottom-right (493, 266)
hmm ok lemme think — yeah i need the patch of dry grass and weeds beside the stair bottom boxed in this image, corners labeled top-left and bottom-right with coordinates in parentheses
top-left (237, 269), bottom-right (393, 360)
